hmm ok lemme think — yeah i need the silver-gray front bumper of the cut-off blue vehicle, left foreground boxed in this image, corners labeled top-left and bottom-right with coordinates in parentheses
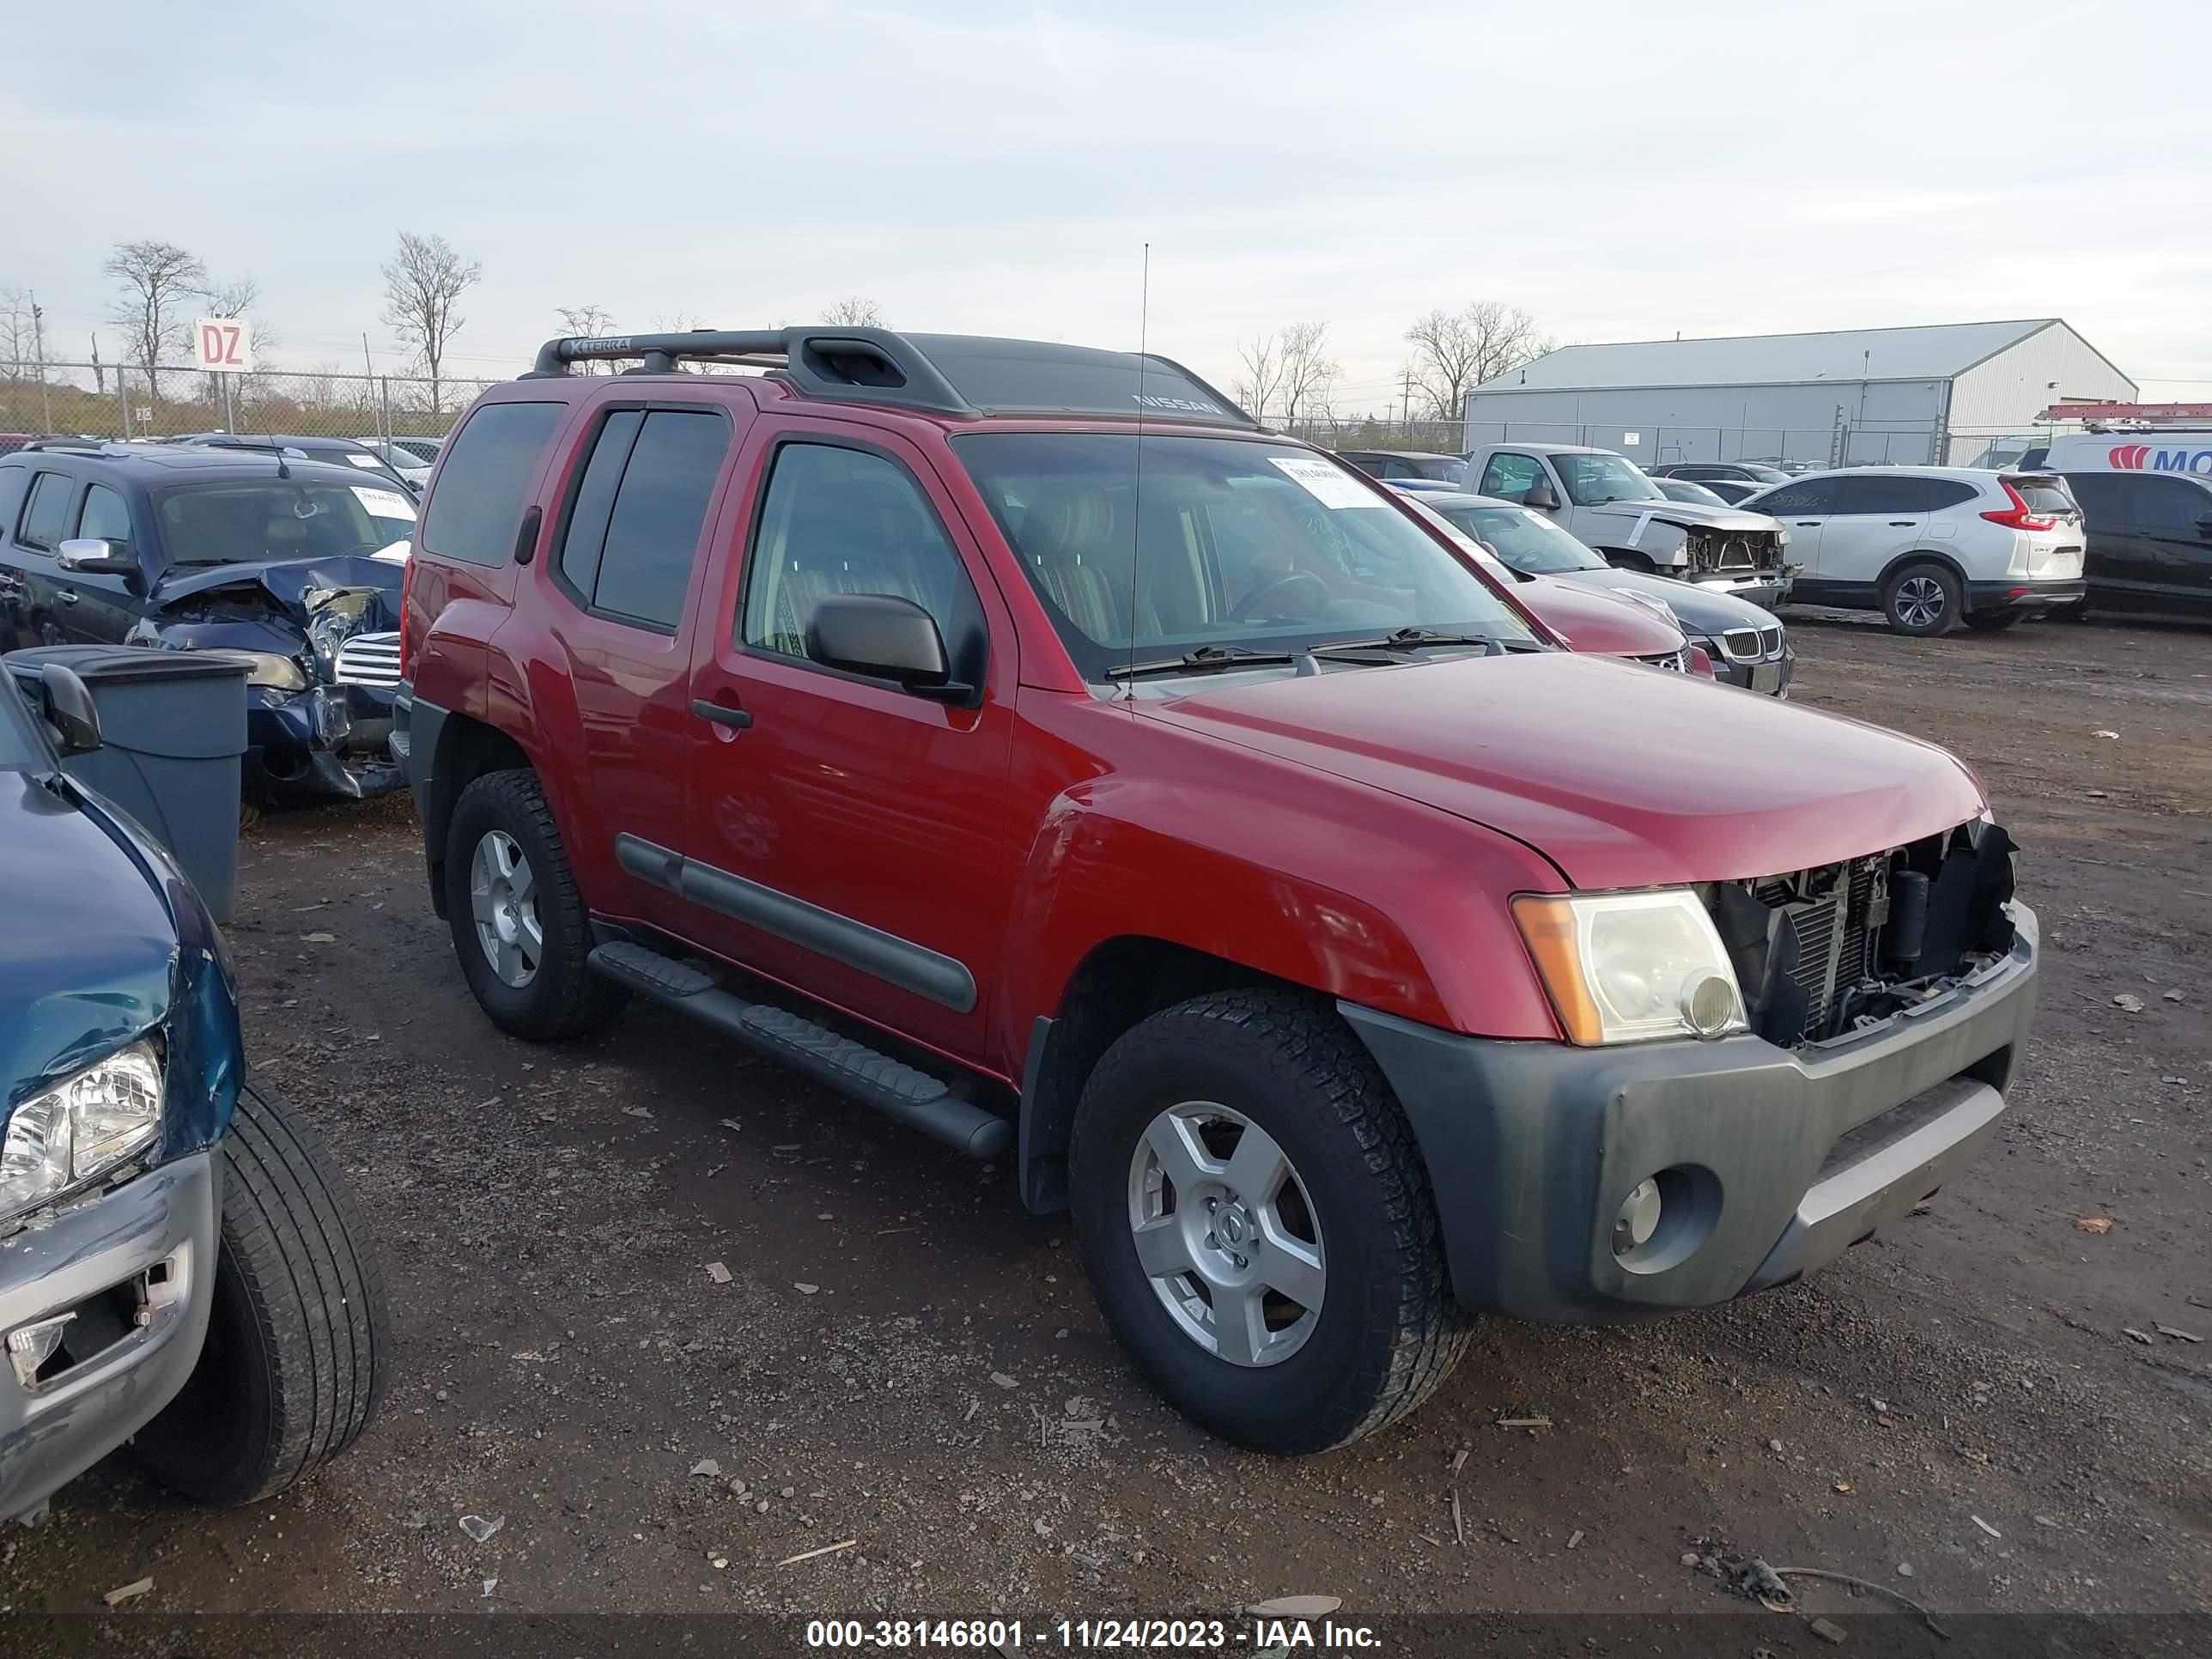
top-left (0, 1151), bottom-right (222, 1520)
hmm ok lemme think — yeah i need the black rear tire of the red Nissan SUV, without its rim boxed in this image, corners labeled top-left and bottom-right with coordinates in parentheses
top-left (445, 769), bottom-right (630, 1042)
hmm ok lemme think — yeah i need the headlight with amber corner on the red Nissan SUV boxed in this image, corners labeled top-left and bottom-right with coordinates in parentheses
top-left (1513, 887), bottom-right (1743, 1046)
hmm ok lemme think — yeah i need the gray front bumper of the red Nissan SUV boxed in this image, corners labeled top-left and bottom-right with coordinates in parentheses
top-left (1338, 905), bottom-right (2037, 1322)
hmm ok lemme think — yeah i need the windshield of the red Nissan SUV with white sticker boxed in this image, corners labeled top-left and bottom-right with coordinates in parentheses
top-left (953, 434), bottom-right (1535, 681)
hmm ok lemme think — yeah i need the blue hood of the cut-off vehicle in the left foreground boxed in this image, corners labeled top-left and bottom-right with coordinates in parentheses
top-left (0, 772), bottom-right (177, 1106)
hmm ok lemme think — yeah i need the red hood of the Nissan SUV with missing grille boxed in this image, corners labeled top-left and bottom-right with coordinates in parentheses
top-left (1137, 653), bottom-right (1984, 890)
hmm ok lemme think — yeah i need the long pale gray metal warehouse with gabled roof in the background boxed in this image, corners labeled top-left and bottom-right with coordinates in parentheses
top-left (1467, 316), bottom-right (2136, 467)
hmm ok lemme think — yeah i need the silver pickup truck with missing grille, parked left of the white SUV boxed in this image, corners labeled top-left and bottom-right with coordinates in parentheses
top-left (1467, 442), bottom-right (1794, 608)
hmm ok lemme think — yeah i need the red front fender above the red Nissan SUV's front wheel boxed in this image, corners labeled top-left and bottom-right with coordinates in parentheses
top-left (994, 775), bottom-right (1562, 1055)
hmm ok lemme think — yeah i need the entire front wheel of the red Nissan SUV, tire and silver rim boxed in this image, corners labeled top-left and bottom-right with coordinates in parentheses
top-left (1068, 991), bottom-right (1468, 1453)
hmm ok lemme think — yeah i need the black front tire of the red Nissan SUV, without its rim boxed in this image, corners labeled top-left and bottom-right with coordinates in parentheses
top-left (1068, 988), bottom-right (1471, 1453)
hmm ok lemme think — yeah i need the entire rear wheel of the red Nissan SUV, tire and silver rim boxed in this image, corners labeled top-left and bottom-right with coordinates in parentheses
top-left (445, 772), bottom-right (629, 1042)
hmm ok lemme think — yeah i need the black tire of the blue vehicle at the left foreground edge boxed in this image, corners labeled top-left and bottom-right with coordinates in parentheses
top-left (135, 1079), bottom-right (392, 1506)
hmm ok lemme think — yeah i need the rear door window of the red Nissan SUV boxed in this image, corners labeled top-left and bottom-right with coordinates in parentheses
top-left (553, 410), bottom-right (730, 633)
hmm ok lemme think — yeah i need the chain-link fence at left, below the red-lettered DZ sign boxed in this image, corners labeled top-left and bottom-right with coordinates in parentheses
top-left (0, 362), bottom-right (491, 441)
